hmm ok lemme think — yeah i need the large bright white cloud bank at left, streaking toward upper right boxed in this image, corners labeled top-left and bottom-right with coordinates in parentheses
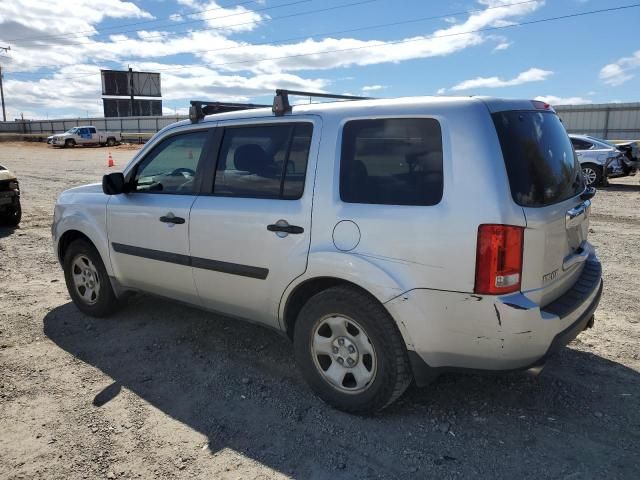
top-left (0, 0), bottom-right (544, 114)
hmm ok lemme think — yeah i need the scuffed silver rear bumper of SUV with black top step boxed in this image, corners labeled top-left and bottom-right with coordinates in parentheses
top-left (386, 254), bottom-right (602, 380)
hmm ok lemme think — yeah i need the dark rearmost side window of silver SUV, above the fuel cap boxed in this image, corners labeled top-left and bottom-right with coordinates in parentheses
top-left (340, 118), bottom-right (443, 206)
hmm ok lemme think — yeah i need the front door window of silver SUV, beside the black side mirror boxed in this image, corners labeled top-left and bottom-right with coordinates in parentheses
top-left (133, 130), bottom-right (208, 194)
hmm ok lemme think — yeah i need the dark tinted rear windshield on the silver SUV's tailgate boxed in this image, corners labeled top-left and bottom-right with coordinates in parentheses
top-left (492, 111), bottom-right (584, 207)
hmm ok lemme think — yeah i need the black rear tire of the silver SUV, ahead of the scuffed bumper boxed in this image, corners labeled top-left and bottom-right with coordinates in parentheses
top-left (294, 286), bottom-right (413, 414)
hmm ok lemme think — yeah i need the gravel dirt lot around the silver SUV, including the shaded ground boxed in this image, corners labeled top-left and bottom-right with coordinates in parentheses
top-left (0, 143), bottom-right (640, 479)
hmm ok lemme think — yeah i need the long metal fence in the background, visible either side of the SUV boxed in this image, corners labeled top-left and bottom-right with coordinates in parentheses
top-left (0, 102), bottom-right (640, 140)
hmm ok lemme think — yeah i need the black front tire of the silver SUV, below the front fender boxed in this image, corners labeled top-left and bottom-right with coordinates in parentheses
top-left (62, 240), bottom-right (120, 317)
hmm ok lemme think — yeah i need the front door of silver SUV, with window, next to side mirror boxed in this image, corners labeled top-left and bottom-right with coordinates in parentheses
top-left (107, 130), bottom-right (209, 303)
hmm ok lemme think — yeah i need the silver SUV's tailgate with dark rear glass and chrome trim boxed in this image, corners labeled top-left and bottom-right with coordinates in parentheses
top-left (492, 109), bottom-right (590, 305)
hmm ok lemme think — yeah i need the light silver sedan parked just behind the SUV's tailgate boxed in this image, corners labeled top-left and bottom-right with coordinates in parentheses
top-left (569, 134), bottom-right (635, 186)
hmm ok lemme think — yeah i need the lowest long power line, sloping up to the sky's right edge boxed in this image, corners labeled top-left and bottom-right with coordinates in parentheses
top-left (6, 3), bottom-right (640, 80)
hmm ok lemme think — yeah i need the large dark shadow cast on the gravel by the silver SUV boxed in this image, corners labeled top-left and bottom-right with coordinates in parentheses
top-left (44, 296), bottom-right (640, 478)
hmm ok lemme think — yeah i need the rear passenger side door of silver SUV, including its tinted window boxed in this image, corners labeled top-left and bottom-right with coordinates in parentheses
top-left (190, 117), bottom-right (321, 326)
